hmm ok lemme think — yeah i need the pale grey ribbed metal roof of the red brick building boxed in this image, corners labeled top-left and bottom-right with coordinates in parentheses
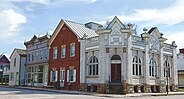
top-left (63, 20), bottom-right (98, 38)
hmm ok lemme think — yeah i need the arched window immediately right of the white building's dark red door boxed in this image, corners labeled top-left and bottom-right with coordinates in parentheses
top-left (132, 56), bottom-right (142, 75)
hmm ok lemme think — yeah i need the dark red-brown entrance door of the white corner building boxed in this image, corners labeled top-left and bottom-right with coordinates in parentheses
top-left (111, 64), bottom-right (121, 83)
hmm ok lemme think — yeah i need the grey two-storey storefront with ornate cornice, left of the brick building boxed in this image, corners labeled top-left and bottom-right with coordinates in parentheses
top-left (24, 34), bottom-right (50, 86)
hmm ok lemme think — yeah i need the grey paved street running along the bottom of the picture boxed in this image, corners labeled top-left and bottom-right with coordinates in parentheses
top-left (0, 87), bottom-right (184, 99)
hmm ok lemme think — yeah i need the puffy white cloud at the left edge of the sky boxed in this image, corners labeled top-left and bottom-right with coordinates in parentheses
top-left (0, 9), bottom-right (27, 40)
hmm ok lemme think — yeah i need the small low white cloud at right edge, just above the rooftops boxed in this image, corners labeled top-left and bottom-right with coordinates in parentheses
top-left (165, 31), bottom-right (184, 49)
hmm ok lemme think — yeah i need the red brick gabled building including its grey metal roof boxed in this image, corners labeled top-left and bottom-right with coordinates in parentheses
top-left (48, 20), bottom-right (95, 90)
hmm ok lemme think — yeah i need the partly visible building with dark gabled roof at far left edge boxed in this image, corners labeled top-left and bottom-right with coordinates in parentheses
top-left (0, 54), bottom-right (10, 84)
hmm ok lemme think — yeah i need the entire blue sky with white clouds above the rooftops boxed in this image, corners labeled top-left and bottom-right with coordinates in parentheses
top-left (0, 0), bottom-right (184, 54)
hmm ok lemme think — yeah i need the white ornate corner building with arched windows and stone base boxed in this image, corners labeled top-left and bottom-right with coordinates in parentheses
top-left (80, 17), bottom-right (178, 94)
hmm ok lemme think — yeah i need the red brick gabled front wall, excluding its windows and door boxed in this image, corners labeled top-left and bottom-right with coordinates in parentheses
top-left (48, 24), bottom-right (80, 90)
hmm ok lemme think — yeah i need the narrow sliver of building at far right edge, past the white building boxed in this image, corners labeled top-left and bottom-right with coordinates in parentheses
top-left (177, 48), bottom-right (184, 88)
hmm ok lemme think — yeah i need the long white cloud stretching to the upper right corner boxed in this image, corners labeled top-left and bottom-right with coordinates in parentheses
top-left (108, 0), bottom-right (184, 25)
